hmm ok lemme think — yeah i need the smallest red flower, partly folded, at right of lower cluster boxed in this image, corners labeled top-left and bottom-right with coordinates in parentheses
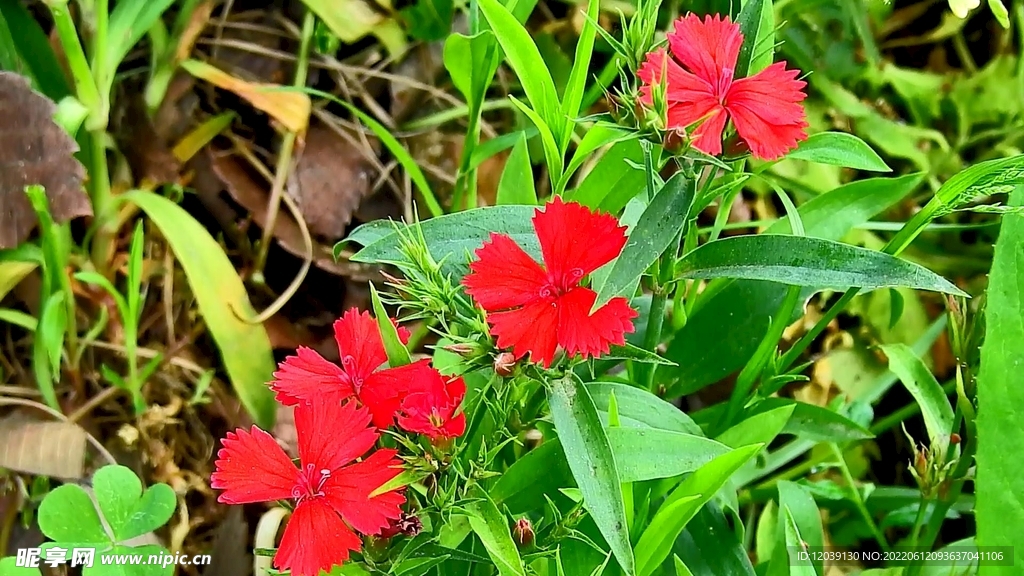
top-left (398, 370), bottom-right (466, 440)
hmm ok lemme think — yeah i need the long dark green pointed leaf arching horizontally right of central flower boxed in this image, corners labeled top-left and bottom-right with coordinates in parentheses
top-left (676, 234), bottom-right (967, 296)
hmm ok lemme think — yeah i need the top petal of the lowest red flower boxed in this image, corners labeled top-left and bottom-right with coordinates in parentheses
top-left (295, 401), bottom-right (379, 471)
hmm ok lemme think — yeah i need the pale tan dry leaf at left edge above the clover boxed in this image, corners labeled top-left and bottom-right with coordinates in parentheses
top-left (0, 412), bottom-right (86, 480)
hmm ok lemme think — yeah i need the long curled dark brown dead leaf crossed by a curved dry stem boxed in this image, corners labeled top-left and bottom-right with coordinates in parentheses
top-left (207, 149), bottom-right (375, 280)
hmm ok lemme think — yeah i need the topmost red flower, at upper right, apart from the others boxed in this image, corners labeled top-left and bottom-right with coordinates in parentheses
top-left (637, 13), bottom-right (807, 160)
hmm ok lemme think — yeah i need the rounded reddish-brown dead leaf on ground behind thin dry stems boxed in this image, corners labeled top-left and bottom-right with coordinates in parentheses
top-left (288, 123), bottom-right (374, 243)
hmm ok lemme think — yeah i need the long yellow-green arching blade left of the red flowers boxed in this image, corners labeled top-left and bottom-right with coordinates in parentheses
top-left (123, 191), bottom-right (276, 429)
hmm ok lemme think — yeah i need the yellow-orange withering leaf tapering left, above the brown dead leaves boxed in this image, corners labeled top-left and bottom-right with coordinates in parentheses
top-left (181, 59), bottom-right (312, 132)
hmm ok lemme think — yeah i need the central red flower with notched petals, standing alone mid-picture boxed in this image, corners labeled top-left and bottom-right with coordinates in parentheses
top-left (463, 197), bottom-right (639, 367)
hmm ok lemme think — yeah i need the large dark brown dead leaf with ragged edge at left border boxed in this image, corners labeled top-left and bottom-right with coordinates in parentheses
top-left (0, 72), bottom-right (92, 249)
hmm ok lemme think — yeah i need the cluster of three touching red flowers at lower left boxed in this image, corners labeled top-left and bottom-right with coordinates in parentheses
top-left (211, 308), bottom-right (466, 576)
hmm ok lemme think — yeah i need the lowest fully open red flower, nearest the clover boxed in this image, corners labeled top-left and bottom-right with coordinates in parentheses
top-left (211, 402), bottom-right (406, 576)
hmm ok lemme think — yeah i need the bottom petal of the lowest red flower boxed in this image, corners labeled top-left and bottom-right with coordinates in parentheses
top-left (273, 498), bottom-right (362, 576)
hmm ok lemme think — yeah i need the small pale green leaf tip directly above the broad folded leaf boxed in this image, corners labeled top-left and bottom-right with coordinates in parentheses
top-left (587, 382), bottom-right (703, 436)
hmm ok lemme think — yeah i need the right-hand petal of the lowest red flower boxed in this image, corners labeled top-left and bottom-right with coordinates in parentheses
top-left (324, 450), bottom-right (406, 534)
